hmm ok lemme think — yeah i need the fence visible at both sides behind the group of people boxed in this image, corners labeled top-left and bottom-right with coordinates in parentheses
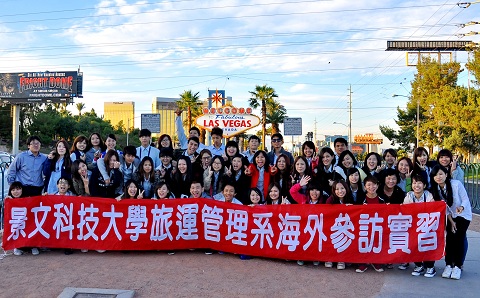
top-left (0, 161), bottom-right (480, 230)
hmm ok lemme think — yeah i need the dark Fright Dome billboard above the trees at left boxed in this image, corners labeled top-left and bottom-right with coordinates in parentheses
top-left (0, 71), bottom-right (83, 103)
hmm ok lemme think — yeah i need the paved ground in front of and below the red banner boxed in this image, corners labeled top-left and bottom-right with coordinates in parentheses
top-left (0, 215), bottom-right (480, 298)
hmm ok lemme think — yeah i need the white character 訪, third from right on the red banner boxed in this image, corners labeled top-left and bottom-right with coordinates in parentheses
top-left (358, 212), bottom-right (383, 253)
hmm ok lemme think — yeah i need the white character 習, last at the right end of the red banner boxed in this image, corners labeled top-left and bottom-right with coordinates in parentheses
top-left (417, 212), bottom-right (440, 251)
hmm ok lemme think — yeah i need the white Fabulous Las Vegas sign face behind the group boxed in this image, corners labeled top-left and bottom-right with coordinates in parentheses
top-left (195, 106), bottom-right (260, 138)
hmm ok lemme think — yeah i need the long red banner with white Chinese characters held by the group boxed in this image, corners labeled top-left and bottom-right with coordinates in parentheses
top-left (3, 196), bottom-right (445, 263)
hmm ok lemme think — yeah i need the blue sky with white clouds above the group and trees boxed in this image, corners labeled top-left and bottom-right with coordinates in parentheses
top-left (0, 0), bottom-right (480, 147)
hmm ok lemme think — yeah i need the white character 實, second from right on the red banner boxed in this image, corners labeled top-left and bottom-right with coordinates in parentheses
top-left (388, 213), bottom-right (412, 254)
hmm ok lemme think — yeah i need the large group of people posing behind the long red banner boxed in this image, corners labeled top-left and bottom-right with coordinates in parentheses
top-left (8, 113), bottom-right (472, 279)
